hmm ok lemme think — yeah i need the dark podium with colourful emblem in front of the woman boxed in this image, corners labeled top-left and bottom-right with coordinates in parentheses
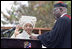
top-left (1, 37), bottom-right (42, 48)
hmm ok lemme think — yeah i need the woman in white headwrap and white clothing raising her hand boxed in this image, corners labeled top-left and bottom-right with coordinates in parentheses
top-left (11, 16), bottom-right (38, 39)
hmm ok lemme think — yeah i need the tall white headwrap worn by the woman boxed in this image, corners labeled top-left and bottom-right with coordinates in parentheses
top-left (19, 16), bottom-right (37, 28)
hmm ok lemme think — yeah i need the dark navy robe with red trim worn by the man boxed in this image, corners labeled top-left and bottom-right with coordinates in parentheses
top-left (37, 16), bottom-right (71, 48)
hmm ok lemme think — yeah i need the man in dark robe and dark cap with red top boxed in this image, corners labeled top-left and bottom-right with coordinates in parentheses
top-left (30, 2), bottom-right (71, 48)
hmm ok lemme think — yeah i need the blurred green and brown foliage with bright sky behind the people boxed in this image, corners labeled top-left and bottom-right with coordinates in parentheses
top-left (1, 1), bottom-right (71, 28)
